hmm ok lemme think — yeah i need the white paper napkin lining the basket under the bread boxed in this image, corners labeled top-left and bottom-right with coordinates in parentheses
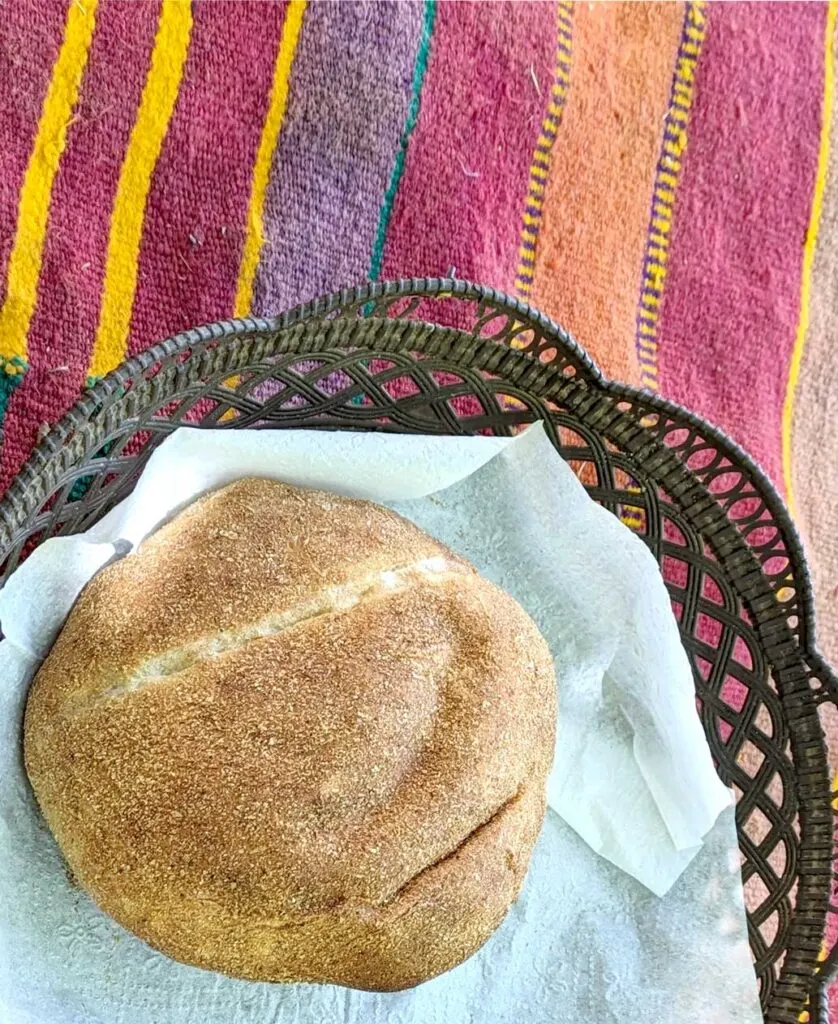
top-left (0, 427), bottom-right (759, 1024)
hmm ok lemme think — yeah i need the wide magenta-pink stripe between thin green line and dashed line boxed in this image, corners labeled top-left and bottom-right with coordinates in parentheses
top-left (382, 3), bottom-right (555, 291)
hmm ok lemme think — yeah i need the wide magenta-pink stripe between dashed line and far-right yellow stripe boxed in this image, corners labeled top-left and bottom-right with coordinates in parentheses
top-left (659, 3), bottom-right (826, 486)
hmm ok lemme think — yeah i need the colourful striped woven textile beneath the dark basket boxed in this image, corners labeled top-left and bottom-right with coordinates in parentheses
top-left (0, 0), bottom-right (838, 1009)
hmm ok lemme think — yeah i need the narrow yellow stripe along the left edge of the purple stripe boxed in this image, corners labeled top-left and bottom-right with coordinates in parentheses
top-left (235, 0), bottom-right (306, 316)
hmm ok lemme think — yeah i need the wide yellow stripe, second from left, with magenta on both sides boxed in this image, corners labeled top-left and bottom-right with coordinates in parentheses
top-left (89, 0), bottom-right (192, 377)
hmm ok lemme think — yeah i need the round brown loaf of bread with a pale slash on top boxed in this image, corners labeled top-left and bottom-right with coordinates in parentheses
top-left (25, 479), bottom-right (555, 989)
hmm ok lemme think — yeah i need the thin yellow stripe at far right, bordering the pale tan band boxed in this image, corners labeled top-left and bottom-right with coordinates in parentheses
top-left (783, 0), bottom-right (838, 515)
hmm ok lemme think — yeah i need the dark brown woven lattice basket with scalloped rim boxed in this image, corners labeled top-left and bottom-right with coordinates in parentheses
top-left (0, 280), bottom-right (838, 1024)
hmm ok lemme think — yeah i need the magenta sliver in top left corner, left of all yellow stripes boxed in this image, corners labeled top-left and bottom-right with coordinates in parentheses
top-left (0, 3), bottom-right (67, 302)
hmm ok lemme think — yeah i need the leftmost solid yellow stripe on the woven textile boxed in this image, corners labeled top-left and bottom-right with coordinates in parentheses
top-left (0, 0), bottom-right (96, 360)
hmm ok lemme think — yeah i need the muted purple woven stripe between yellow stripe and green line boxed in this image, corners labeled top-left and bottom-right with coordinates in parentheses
top-left (253, 2), bottom-right (422, 314)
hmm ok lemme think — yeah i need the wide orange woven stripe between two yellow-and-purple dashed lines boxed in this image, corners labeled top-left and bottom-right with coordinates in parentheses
top-left (532, 3), bottom-right (684, 384)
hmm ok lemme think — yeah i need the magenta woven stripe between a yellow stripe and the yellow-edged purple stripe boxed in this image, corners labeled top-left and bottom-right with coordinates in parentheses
top-left (128, 2), bottom-right (285, 352)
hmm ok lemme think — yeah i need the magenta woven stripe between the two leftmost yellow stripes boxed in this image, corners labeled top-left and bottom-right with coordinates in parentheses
top-left (0, 2), bottom-right (159, 489)
